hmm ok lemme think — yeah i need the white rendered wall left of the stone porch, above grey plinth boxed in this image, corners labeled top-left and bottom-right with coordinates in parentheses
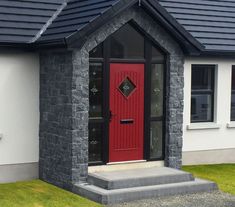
top-left (0, 52), bottom-right (39, 165)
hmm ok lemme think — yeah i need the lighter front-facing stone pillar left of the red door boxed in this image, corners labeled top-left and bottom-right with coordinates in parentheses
top-left (72, 50), bottom-right (89, 183)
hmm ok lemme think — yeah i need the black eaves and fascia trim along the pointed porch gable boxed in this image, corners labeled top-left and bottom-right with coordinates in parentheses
top-left (34, 0), bottom-right (204, 55)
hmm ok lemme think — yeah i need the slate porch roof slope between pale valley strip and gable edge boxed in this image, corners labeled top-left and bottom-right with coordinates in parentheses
top-left (39, 0), bottom-right (119, 41)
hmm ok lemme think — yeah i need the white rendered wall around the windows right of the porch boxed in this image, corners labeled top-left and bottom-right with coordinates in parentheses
top-left (183, 58), bottom-right (235, 153)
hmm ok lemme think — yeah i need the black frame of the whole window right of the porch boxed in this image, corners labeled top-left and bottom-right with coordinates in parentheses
top-left (190, 64), bottom-right (216, 123)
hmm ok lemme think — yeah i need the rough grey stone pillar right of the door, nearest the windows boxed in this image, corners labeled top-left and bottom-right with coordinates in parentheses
top-left (165, 54), bottom-right (184, 169)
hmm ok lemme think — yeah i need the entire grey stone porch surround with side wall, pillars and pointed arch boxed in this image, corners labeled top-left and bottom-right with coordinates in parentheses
top-left (40, 5), bottom-right (184, 189)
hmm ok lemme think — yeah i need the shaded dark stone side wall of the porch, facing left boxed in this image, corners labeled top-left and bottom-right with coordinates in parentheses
top-left (39, 52), bottom-right (73, 189)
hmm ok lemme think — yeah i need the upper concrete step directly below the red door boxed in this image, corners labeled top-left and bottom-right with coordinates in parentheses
top-left (87, 167), bottom-right (194, 190)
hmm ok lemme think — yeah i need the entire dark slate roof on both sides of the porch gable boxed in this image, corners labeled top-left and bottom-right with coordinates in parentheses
top-left (0, 0), bottom-right (235, 52)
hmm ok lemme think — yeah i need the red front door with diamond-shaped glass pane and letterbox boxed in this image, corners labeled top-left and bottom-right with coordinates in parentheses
top-left (109, 64), bottom-right (144, 162)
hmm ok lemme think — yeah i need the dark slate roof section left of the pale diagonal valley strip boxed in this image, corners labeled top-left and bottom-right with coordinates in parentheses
top-left (0, 0), bottom-right (64, 43)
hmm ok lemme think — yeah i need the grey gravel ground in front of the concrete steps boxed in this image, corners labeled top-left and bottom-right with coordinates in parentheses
top-left (111, 191), bottom-right (235, 207)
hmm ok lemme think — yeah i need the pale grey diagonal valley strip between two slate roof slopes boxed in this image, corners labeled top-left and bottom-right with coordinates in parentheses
top-left (29, 0), bottom-right (70, 43)
